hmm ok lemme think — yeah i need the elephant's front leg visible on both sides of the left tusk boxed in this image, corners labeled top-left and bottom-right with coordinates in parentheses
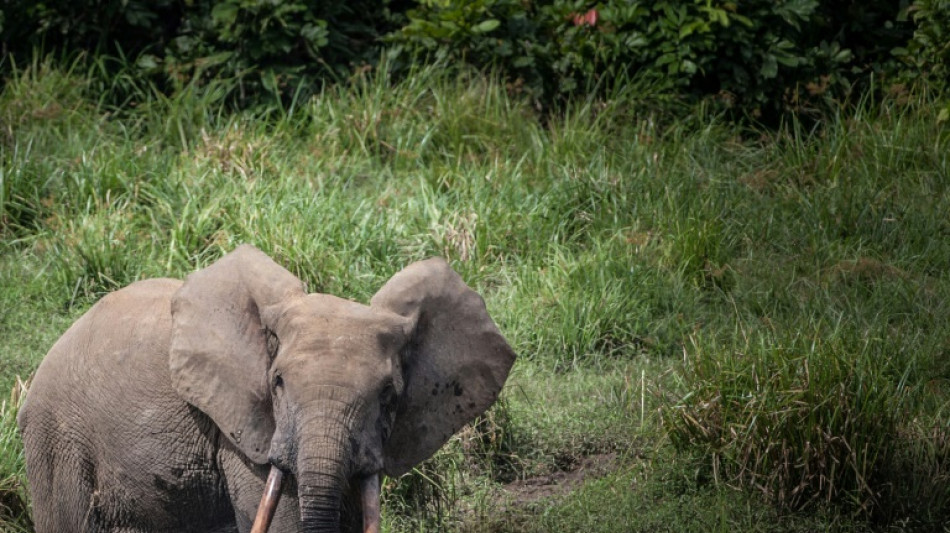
top-left (218, 439), bottom-right (300, 533)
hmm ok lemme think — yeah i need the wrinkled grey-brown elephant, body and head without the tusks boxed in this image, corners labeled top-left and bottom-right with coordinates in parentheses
top-left (18, 245), bottom-right (515, 533)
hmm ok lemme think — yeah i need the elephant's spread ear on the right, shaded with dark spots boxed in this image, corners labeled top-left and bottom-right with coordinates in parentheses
top-left (371, 258), bottom-right (515, 476)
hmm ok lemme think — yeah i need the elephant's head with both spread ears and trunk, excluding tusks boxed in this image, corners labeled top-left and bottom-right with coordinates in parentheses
top-left (169, 245), bottom-right (515, 531)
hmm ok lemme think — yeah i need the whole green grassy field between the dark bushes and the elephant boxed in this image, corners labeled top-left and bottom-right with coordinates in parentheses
top-left (0, 63), bottom-right (950, 532)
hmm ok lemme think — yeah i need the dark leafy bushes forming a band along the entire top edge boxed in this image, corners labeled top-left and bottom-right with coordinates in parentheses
top-left (0, 0), bottom-right (936, 116)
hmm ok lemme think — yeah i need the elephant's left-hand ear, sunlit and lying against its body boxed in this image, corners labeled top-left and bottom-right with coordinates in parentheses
top-left (169, 245), bottom-right (304, 464)
